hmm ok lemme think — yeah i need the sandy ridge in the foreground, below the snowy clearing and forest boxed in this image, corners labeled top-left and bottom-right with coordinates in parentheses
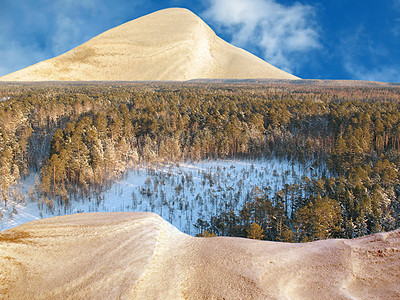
top-left (0, 213), bottom-right (400, 299)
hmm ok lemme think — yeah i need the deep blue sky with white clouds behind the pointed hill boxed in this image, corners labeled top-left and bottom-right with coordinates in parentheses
top-left (0, 0), bottom-right (400, 82)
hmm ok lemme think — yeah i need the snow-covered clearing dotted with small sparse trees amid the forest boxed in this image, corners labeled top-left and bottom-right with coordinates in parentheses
top-left (0, 159), bottom-right (322, 235)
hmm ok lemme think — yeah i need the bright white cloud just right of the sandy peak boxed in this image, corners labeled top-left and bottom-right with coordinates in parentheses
top-left (204, 0), bottom-right (321, 71)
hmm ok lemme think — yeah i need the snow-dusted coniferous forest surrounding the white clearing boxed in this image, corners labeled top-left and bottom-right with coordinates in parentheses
top-left (0, 81), bottom-right (400, 242)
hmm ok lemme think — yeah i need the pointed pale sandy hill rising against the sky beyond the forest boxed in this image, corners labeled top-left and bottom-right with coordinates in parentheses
top-left (0, 8), bottom-right (297, 81)
